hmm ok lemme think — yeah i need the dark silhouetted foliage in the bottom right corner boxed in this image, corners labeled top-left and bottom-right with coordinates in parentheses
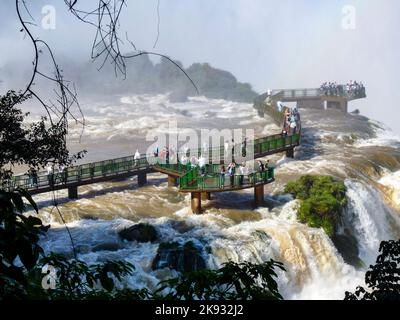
top-left (345, 240), bottom-right (400, 301)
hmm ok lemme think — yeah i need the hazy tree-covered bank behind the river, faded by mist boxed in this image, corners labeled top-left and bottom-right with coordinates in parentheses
top-left (70, 56), bottom-right (257, 102)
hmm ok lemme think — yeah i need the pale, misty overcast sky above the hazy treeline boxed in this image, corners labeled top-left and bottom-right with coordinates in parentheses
top-left (0, 0), bottom-right (400, 133)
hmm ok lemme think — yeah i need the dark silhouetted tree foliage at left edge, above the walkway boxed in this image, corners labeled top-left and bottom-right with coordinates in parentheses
top-left (0, 90), bottom-right (84, 183)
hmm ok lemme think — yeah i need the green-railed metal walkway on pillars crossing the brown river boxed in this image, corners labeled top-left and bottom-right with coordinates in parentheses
top-left (4, 86), bottom-right (318, 213)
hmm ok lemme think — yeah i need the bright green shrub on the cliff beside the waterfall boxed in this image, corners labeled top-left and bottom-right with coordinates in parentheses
top-left (285, 175), bottom-right (347, 237)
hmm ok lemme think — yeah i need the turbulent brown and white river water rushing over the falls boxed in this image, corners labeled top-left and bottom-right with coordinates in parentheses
top-left (29, 95), bottom-right (400, 299)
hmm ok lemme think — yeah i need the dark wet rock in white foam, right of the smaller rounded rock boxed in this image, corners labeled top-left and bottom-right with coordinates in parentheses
top-left (152, 241), bottom-right (206, 272)
